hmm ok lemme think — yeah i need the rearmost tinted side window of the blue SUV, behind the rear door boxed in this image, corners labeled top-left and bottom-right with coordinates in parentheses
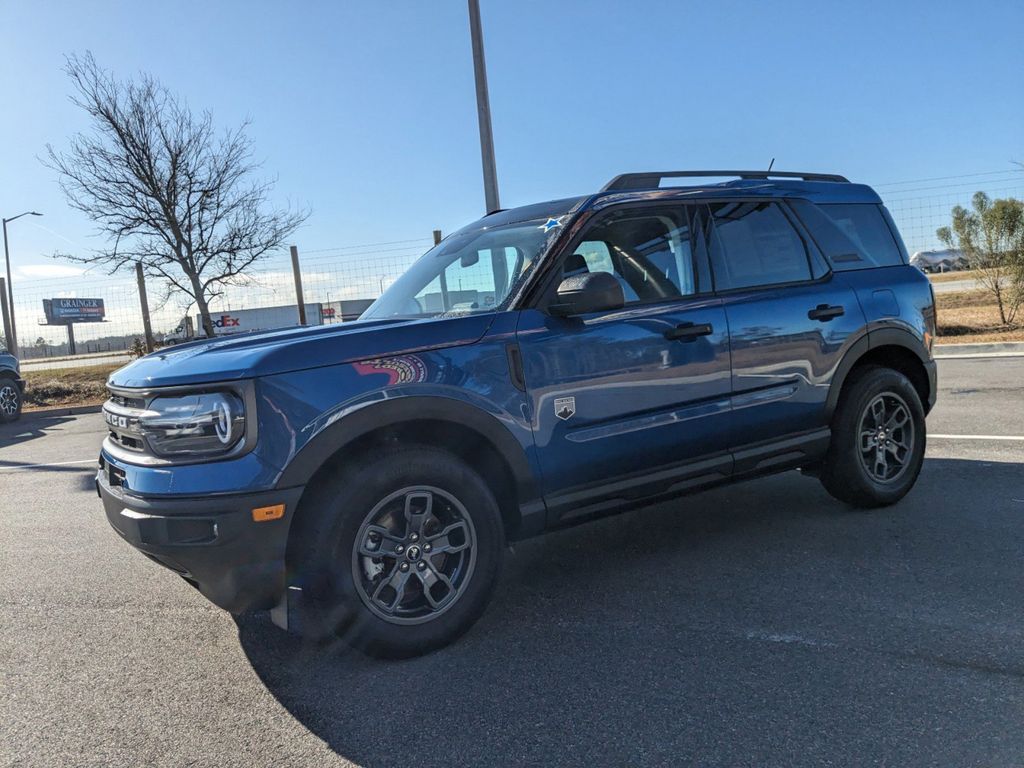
top-left (793, 200), bottom-right (903, 270)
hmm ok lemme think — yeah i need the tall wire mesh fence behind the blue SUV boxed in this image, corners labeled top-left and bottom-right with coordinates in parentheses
top-left (4, 170), bottom-right (1024, 360)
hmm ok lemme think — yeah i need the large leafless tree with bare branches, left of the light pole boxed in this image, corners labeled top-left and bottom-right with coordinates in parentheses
top-left (44, 53), bottom-right (308, 337)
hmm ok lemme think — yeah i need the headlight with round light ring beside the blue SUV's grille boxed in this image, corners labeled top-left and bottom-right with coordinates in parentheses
top-left (138, 392), bottom-right (246, 457)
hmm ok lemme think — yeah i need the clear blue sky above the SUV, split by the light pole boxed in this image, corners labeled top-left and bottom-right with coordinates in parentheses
top-left (0, 0), bottom-right (1024, 278)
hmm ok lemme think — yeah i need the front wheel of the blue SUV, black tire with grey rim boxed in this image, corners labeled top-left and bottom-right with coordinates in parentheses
top-left (292, 446), bottom-right (504, 658)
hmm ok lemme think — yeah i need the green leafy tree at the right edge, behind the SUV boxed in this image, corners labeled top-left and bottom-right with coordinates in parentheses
top-left (936, 191), bottom-right (1024, 326)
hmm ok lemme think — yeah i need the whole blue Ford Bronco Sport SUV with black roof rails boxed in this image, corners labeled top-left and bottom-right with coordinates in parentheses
top-left (97, 171), bottom-right (936, 656)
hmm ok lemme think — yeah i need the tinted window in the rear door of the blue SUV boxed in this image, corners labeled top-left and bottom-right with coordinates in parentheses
top-left (711, 202), bottom-right (811, 291)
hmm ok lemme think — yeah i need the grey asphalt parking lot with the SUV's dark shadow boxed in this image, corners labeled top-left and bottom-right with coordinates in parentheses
top-left (0, 357), bottom-right (1024, 768)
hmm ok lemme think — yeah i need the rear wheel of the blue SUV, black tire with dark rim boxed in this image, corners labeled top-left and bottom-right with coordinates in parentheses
top-left (820, 366), bottom-right (926, 509)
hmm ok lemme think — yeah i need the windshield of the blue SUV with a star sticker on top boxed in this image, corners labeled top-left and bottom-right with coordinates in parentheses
top-left (360, 218), bottom-right (563, 319)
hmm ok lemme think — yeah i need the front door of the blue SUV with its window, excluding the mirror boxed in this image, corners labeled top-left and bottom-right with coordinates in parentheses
top-left (517, 205), bottom-right (731, 521)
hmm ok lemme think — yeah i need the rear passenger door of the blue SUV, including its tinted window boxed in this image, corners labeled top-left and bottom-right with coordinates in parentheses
top-left (708, 201), bottom-right (864, 450)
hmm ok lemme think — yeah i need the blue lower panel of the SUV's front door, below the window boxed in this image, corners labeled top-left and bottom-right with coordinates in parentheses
top-left (517, 298), bottom-right (730, 516)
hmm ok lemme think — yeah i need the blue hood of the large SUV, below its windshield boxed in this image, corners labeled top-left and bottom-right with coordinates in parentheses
top-left (108, 314), bottom-right (494, 388)
